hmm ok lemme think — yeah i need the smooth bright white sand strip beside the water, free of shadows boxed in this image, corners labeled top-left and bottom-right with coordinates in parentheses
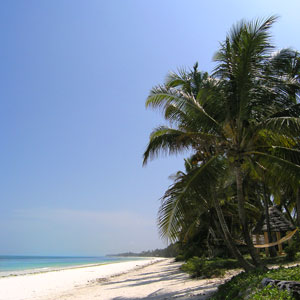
top-left (0, 258), bottom-right (165, 300)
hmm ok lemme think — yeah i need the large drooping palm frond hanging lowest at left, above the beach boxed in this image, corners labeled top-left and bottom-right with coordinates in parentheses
top-left (158, 156), bottom-right (226, 241)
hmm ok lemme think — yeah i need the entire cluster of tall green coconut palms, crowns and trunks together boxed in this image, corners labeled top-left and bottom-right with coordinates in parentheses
top-left (144, 16), bottom-right (300, 272)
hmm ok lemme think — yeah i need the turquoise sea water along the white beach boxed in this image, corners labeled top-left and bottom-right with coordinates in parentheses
top-left (0, 256), bottom-right (142, 277)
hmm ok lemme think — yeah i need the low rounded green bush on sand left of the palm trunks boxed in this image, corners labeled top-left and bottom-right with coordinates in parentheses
top-left (181, 256), bottom-right (225, 278)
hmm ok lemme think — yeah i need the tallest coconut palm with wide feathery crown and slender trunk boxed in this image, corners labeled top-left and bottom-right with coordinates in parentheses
top-left (144, 17), bottom-right (300, 269)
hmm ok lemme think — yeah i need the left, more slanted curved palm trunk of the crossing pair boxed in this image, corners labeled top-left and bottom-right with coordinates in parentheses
top-left (212, 192), bottom-right (255, 272)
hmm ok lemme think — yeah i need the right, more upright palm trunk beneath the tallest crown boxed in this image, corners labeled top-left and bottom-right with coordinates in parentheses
top-left (235, 166), bottom-right (264, 268)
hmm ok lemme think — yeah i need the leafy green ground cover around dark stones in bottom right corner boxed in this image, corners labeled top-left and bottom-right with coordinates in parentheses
top-left (211, 266), bottom-right (300, 300)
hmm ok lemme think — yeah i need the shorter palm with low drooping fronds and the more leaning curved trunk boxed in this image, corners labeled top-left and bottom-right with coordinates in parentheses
top-left (158, 159), bottom-right (259, 269)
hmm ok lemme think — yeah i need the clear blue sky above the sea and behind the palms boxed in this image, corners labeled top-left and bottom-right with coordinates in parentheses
top-left (0, 0), bottom-right (300, 256)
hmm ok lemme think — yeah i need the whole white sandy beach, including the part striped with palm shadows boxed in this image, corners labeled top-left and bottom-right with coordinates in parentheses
top-left (0, 258), bottom-right (237, 300)
